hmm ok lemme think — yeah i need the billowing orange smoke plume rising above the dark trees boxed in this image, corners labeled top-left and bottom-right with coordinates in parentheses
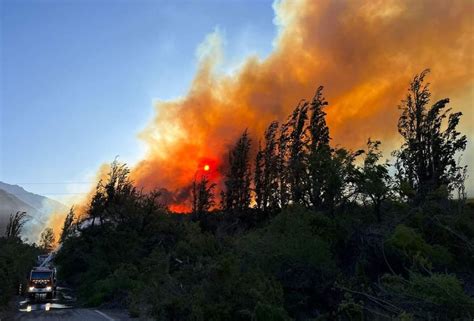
top-left (132, 0), bottom-right (474, 211)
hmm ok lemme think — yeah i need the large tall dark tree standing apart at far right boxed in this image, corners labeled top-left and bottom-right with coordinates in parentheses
top-left (395, 69), bottom-right (467, 203)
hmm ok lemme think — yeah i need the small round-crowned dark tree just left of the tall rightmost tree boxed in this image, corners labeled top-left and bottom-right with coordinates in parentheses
top-left (356, 139), bottom-right (391, 222)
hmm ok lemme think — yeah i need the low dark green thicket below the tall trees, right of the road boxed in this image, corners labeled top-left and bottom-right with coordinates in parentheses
top-left (51, 168), bottom-right (472, 321)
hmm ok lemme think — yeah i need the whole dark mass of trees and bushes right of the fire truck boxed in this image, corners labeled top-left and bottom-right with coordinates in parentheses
top-left (53, 71), bottom-right (474, 321)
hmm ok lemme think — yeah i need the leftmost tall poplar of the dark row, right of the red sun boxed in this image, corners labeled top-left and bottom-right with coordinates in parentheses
top-left (224, 130), bottom-right (251, 211)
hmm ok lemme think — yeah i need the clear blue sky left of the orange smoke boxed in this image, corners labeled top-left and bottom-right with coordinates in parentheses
top-left (0, 0), bottom-right (277, 198)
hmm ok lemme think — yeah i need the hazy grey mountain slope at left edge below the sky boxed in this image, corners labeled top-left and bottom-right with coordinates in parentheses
top-left (0, 182), bottom-right (68, 241)
